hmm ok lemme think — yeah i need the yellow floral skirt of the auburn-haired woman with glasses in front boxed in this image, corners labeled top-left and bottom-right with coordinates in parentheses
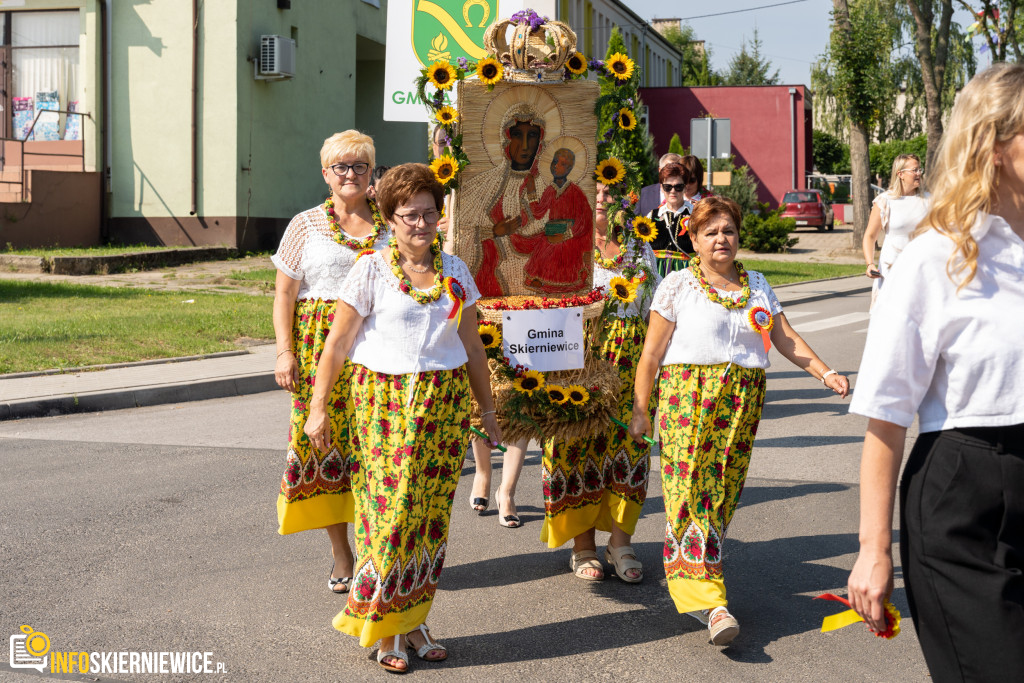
top-left (334, 365), bottom-right (470, 647)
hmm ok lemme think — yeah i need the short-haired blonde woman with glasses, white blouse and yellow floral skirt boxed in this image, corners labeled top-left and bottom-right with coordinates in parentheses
top-left (271, 130), bottom-right (389, 593)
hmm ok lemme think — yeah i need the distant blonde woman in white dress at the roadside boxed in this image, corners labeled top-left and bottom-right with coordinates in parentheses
top-left (861, 155), bottom-right (928, 298)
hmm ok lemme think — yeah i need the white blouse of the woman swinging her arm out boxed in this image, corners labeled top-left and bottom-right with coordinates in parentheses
top-left (650, 268), bottom-right (782, 369)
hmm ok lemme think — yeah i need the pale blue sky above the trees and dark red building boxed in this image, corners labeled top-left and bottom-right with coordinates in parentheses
top-left (624, 0), bottom-right (988, 86)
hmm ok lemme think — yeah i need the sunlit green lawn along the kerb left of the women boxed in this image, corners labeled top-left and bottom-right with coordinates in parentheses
top-left (0, 280), bottom-right (273, 374)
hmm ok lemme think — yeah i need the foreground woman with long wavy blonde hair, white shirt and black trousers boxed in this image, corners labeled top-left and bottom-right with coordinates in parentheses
top-left (849, 63), bottom-right (1024, 681)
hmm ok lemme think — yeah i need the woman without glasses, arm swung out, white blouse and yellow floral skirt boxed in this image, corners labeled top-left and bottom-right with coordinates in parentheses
top-left (630, 197), bottom-right (849, 645)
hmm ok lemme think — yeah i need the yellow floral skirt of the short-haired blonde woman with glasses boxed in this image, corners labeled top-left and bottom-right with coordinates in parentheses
top-left (278, 299), bottom-right (354, 533)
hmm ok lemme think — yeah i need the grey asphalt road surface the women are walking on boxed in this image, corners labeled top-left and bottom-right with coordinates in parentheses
top-left (0, 295), bottom-right (928, 681)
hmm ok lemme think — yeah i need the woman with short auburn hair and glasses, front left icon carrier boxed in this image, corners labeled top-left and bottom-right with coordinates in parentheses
top-left (305, 164), bottom-right (501, 673)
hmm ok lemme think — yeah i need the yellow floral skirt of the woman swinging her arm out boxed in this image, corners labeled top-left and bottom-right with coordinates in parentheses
top-left (658, 364), bottom-right (765, 612)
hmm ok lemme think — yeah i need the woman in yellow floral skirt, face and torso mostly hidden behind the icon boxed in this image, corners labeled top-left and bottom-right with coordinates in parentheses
top-left (541, 183), bottom-right (660, 584)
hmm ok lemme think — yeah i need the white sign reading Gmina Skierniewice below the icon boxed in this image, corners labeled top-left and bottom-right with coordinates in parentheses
top-left (502, 308), bottom-right (585, 372)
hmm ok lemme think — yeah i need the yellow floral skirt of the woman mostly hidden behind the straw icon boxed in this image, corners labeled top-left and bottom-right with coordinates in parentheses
top-left (541, 317), bottom-right (656, 548)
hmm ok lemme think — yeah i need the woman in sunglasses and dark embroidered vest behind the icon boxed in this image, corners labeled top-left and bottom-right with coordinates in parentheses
top-left (647, 155), bottom-right (713, 278)
